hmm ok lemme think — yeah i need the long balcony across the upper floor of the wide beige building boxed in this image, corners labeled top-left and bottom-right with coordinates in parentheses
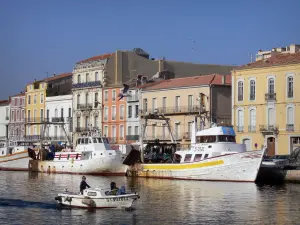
top-left (141, 106), bottom-right (200, 116)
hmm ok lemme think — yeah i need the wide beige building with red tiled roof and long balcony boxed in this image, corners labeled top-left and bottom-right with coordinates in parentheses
top-left (140, 74), bottom-right (231, 147)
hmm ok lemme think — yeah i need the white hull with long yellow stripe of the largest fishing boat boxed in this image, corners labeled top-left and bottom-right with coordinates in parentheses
top-left (127, 150), bottom-right (264, 182)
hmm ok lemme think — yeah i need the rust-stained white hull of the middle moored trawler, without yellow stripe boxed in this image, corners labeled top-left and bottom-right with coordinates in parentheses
top-left (29, 156), bottom-right (127, 176)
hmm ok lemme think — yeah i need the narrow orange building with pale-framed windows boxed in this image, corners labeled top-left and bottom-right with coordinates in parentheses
top-left (102, 87), bottom-right (126, 144)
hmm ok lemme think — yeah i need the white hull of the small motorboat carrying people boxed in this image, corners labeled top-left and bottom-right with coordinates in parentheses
top-left (55, 194), bottom-right (139, 209)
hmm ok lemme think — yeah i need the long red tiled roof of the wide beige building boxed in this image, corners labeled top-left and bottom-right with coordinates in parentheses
top-left (140, 74), bottom-right (231, 90)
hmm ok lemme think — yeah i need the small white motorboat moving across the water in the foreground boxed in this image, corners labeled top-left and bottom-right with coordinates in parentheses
top-left (55, 188), bottom-right (140, 209)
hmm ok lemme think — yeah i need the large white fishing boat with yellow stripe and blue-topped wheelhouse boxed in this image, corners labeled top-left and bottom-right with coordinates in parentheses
top-left (125, 115), bottom-right (266, 182)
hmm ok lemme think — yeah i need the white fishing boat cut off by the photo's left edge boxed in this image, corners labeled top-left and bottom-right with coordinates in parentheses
top-left (0, 141), bottom-right (34, 171)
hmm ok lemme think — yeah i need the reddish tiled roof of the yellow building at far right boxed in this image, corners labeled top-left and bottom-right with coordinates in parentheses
top-left (236, 52), bottom-right (300, 70)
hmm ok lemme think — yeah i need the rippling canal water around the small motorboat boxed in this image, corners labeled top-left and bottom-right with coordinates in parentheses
top-left (0, 171), bottom-right (300, 225)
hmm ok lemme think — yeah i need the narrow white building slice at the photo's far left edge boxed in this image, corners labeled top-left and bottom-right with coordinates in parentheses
top-left (0, 100), bottom-right (10, 140)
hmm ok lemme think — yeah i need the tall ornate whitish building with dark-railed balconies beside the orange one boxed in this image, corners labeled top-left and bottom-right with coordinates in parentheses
top-left (72, 54), bottom-right (113, 142)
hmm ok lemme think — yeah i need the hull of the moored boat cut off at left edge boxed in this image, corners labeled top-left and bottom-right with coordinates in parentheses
top-left (0, 151), bottom-right (31, 171)
